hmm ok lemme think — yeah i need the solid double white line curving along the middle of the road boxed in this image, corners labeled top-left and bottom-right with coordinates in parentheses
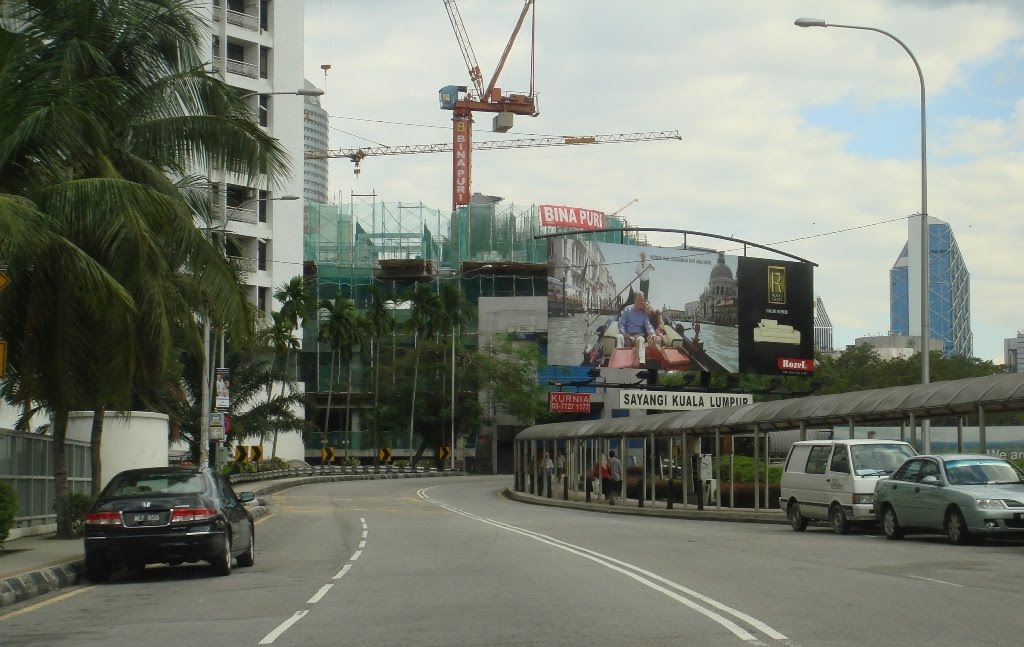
top-left (417, 485), bottom-right (788, 642)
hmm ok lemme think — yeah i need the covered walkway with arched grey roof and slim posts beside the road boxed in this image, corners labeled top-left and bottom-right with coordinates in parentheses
top-left (515, 374), bottom-right (1024, 510)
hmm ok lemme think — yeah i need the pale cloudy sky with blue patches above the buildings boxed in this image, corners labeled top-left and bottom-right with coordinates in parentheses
top-left (305, 0), bottom-right (1024, 363)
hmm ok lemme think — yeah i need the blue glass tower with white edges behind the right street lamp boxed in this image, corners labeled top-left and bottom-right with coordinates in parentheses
top-left (889, 216), bottom-right (974, 357)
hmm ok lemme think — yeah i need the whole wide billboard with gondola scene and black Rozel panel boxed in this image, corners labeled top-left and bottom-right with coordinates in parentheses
top-left (548, 238), bottom-right (814, 375)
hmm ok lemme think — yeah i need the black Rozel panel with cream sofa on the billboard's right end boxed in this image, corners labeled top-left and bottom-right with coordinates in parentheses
top-left (736, 256), bottom-right (814, 375)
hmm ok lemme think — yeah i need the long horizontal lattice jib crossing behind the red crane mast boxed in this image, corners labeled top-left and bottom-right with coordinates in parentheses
top-left (303, 130), bottom-right (682, 181)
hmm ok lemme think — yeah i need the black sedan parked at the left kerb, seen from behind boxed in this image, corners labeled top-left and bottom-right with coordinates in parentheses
top-left (85, 467), bottom-right (256, 581)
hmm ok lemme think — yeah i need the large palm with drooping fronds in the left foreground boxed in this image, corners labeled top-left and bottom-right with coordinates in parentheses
top-left (0, 0), bottom-right (287, 536)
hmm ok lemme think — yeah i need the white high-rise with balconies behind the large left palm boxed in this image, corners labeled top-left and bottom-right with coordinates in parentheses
top-left (199, 0), bottom-right (304, 313)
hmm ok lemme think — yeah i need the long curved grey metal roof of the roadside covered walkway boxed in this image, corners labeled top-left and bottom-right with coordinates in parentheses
top-left (516, 373), bottom-right (1024, 440)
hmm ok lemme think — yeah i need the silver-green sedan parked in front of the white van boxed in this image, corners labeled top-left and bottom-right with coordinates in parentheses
top-left (874, 454), bottom-right (1024, 545)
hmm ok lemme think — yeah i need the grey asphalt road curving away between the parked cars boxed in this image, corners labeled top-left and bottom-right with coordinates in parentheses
top-left (0, 477), bottom-right (1024, 647)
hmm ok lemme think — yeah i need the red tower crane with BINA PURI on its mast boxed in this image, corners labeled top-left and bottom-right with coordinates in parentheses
top-left (439, 0), bottom-right (540, 211)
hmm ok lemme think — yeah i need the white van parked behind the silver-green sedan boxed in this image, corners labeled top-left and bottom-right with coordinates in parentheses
top-left (779, 438), bottom-right (918, 534)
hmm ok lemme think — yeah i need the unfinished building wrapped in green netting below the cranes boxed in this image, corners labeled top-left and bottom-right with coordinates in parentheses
top-left (300, 193), bottom-right (642, 471)
